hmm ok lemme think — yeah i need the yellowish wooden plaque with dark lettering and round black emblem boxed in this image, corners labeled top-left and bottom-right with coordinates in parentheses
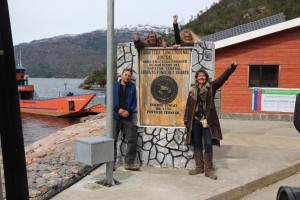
top-left (139, 48), bottom-right (192, 127)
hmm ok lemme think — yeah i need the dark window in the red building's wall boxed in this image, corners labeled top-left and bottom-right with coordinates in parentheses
top-left (249, 65), bottom-right (279, 88)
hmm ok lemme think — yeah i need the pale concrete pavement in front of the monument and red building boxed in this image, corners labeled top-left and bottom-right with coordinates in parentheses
top-left (53, 119), bottom-right (300, 200)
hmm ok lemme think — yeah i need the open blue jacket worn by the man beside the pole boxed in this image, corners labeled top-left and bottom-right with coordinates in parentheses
top-left (114, 80), bottom-right (137, 120)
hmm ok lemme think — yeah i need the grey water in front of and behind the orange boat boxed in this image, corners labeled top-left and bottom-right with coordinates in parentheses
top-left (21, 78), bottom-right (91, 146)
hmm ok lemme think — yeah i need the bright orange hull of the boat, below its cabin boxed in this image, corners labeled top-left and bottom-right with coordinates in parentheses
top-left (20, 94), bottom-right (95, 117)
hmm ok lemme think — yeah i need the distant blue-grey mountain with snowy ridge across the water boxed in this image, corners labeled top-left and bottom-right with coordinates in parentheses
top-left (14, 26), bottom-right (170, 78)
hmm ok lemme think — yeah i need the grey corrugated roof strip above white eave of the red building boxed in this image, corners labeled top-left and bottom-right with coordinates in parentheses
top-left (202, 13), bottom-right (285, 42)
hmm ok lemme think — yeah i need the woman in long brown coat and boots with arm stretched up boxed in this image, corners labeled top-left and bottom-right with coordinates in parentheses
top-left (184, 62), bottom-right (237, 180)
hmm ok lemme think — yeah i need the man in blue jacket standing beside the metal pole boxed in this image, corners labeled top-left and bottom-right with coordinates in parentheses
top-left (113, 69), bottom-right (140, 170)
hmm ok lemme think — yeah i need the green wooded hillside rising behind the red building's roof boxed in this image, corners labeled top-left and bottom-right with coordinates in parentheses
top-left (183, 0), bottom-right (300, 36)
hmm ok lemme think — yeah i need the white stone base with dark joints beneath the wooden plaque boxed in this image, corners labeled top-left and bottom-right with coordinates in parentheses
top-left (117, 127), bottom-right (195, 168)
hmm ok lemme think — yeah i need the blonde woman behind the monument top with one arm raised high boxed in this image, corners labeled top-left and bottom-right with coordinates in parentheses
top-left (173, 15), bottom-right (200, 49)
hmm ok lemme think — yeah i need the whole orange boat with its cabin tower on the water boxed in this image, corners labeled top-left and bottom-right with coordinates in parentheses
top-left (16, 65), bottom-right (96, 117)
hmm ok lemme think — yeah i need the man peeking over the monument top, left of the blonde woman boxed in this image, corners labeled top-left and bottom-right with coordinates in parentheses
top-left (133, 31), bottom-right (167, 49)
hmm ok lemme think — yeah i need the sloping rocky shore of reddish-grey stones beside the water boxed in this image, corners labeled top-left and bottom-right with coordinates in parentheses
top-left (1, 116), bottom-right (106, 200)
